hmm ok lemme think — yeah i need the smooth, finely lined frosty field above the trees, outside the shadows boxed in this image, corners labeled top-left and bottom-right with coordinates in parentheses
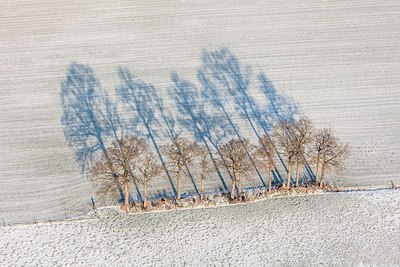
top-left (0, 0), bottom-right (400, 223)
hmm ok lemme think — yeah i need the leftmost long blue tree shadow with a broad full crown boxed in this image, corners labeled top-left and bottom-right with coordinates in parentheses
top-left (61, 62), bottom-right (128, 199)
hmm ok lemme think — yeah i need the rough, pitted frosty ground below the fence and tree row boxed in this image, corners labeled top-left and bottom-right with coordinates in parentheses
top-left (0, 190), bottom-right (400, 266)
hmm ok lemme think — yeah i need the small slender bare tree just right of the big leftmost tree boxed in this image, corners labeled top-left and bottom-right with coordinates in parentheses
top-left (133, 151), bottom-right (163, 209)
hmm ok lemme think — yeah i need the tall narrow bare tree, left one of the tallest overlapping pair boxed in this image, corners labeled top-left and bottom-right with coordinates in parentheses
top-left (272, 120), bottom-right (296, 189)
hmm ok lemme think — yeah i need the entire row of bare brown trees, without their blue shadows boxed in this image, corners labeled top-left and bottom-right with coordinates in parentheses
top-left (91, 117), bottom-right (349, 208)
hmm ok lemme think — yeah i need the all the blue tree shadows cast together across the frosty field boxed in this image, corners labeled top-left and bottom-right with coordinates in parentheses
top-left (61, 48), bottom-right (306, 201)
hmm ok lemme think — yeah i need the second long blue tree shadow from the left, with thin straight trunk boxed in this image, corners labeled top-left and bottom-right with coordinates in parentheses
top-left (116, 67), bottom-right (177, 195)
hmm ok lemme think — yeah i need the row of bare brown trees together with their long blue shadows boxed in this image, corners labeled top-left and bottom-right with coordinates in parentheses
top-left (61, 47), bottom-right (349, 209)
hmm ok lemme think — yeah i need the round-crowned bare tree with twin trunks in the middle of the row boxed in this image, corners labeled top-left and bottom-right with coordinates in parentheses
top-left (219, 139), bottom-right (254, 200)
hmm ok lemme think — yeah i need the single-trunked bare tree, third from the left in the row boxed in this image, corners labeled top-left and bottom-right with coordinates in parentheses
top-left (161, 137), bottom-right (197, 200)
